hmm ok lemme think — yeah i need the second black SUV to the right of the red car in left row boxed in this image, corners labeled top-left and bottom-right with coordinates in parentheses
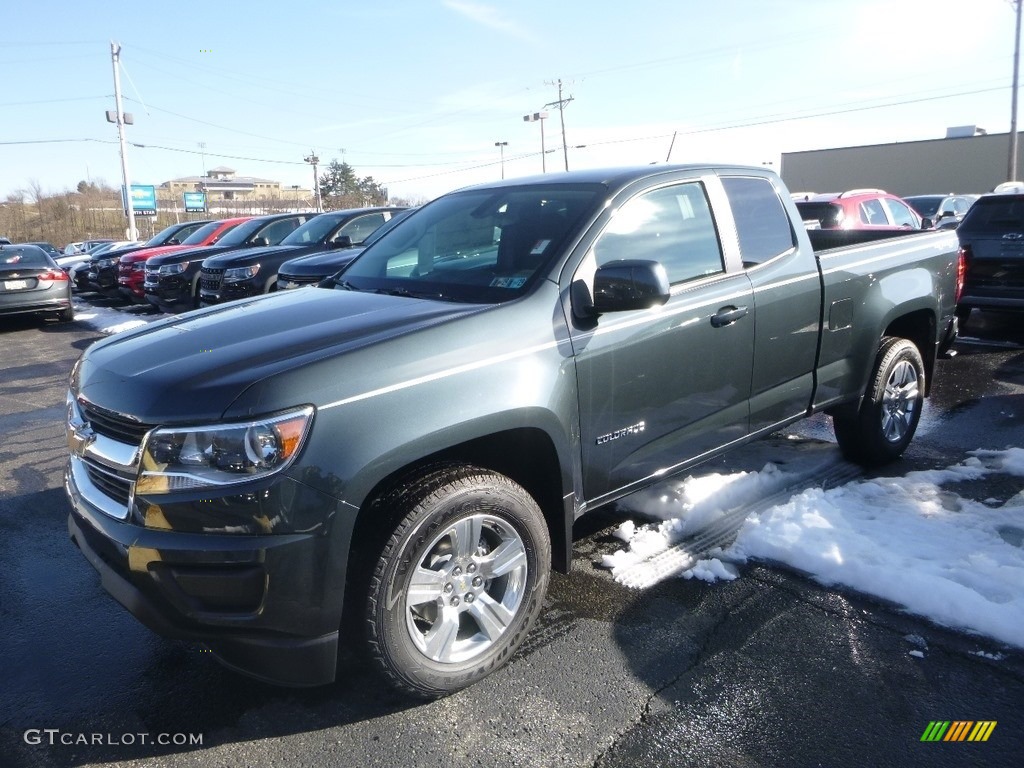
top-left (200, 208), bottom-right (404, 305)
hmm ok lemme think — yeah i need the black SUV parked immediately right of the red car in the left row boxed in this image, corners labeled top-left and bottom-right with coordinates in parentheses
top-left (143, 213), bottom-right (318, 312)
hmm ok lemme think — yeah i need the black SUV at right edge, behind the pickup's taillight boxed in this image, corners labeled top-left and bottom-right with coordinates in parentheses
top-left (956, 191), bottom-right (1024, 324)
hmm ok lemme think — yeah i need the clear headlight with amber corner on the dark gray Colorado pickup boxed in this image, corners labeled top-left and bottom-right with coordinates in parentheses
top-left (135, 406), bottom-right (313, 494)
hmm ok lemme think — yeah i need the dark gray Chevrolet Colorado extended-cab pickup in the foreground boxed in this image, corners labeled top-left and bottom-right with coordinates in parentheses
top-left (66, 166), bottom-right (963, 697)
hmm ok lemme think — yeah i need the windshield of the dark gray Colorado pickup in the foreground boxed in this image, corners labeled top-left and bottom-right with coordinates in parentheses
top-left (334, 184), bottom-right (605, 304)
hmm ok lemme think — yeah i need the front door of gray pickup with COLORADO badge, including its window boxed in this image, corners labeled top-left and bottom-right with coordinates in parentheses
top-left (571, 178), bottom-right (755, 504)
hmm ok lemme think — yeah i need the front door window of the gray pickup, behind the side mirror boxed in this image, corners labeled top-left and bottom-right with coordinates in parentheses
top-left (594, 182), bottom-right (723, 284)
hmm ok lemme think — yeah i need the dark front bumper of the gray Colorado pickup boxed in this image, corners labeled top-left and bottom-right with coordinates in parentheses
top-left (65, 457), bottom-right (347, 686)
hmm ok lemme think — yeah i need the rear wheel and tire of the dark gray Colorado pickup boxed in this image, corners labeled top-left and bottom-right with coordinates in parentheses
top-left (833, 338), bottom-right (925, 467)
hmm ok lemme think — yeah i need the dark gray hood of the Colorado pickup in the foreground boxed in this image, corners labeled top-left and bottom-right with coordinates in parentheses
top-left (76, 289), bottom-right (487, 424)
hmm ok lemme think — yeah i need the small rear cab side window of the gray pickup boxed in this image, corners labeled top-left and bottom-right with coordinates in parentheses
top-left (722, 176), bottom-right (797, 267)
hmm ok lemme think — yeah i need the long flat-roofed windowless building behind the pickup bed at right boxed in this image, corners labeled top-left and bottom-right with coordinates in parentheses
top-left (779, 126), bottom-right (1024, 197)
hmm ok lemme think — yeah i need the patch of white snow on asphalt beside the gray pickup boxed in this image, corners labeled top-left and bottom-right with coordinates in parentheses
top-left (603, 440), bottom-right (1024, 657)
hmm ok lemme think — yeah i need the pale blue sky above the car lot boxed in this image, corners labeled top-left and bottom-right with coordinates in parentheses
top-left (0, 0), bottom-right (1014, 202)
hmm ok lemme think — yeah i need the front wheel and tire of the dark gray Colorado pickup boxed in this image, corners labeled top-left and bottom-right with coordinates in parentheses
top-left (366, 465), bottom-right (551, 698)
